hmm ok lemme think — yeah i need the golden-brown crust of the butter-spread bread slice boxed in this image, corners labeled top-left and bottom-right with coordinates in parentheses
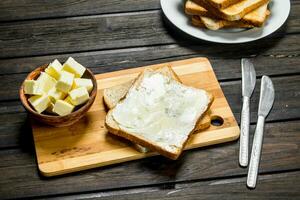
top-left (105, 70), bottom-right (214, 160)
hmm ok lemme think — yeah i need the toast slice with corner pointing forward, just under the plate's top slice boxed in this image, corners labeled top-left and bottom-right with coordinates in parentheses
top-left (193, 0), bottom-right (269, 21)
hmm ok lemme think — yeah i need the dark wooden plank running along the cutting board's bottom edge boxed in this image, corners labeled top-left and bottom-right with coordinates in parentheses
top-left (0, 121), bottom-right (300, 198)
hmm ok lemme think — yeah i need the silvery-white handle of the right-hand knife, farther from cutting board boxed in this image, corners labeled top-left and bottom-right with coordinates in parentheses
top-left (247, 116), bottom-right (265, 188)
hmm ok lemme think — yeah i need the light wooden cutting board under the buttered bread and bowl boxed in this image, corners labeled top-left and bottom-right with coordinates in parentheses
top-left (32, 58), bottom-right (240, 176)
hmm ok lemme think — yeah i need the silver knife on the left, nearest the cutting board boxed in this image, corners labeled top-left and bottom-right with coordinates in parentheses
top-left (239, 58), bottom-right (256, 167)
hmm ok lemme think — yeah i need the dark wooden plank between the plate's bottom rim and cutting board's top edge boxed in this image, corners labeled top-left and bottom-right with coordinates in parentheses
top-left (0, 35), bottom-right (300, 76)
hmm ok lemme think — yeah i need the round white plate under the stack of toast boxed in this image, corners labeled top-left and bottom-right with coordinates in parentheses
top-left (160, 0), bottom-right (290, 44)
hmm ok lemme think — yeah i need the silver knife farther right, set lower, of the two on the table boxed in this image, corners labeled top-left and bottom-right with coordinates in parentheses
top-left (247, 76), bottom-right (275, 188)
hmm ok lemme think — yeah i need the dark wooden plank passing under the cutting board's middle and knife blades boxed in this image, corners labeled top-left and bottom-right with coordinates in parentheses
top-left (0, 75), bottom-right (300, 148)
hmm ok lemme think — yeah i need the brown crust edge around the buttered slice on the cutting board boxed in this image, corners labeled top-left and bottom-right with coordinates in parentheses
top-left (106, 68), bottom-right (213, 159)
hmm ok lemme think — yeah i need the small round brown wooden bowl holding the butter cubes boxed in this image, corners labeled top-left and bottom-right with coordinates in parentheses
top-left (19, 64), bottom-right (97, 127)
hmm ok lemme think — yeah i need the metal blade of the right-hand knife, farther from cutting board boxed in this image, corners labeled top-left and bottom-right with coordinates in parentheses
top-left (258, 76), bottom-right (275, 117)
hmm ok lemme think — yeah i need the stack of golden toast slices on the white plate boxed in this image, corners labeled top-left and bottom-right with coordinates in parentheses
top-left (185, 0), bottom-right (271, 30)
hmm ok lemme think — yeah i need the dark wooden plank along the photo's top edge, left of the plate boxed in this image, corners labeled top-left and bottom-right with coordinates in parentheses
top-left (0, 0), bottom-right (160, 21)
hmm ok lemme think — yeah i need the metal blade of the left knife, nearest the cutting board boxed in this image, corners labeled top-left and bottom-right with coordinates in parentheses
top-left (241, 58), bottom-right (256, 97)
